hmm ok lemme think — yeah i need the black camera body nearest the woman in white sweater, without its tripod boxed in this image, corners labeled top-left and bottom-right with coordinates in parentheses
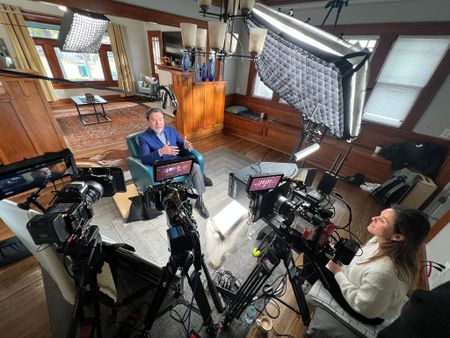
top-left (229, 169), bottom-right (359, 264)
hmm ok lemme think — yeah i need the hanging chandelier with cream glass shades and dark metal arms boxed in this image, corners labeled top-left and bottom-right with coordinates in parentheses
top-left (180, 0), bottom-right (267, 61)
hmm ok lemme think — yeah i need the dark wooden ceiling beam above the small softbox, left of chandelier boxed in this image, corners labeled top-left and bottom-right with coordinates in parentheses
top-left (33, 0), bottom-right (208, 28)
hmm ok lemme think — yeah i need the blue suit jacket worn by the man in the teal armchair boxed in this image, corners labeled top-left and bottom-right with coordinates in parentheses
top-left (139, 126), bottom-right (184, 165)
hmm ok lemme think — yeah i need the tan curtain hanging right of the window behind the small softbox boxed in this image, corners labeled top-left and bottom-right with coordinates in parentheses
top-left (108, 23), bottom-right (135, 96)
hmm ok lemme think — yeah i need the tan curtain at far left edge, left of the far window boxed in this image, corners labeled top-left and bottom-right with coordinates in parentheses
top-left (0, 4), bottom-right (57, 101)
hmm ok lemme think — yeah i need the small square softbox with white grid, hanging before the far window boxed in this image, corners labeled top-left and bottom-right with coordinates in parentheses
top-left (58, 9), bottom-right (109, 53)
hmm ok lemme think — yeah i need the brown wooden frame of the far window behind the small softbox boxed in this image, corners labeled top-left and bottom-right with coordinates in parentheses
top-left (24, 13), bottom-right (119, 89)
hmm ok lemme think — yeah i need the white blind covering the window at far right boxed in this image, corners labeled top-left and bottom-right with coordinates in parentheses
top-left (364, 36), bottom-right (450, 127)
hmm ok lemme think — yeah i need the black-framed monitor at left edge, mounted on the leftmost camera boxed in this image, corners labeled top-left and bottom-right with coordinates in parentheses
top-left (0, 149), bottom-right (74, 200)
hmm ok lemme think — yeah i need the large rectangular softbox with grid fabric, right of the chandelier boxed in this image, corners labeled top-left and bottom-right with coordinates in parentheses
top-left (247, 4), bottom-right (370, 140)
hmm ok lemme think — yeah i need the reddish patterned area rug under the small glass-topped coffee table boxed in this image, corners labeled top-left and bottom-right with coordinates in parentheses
top-left (55, 103), bottom-right (147, 152)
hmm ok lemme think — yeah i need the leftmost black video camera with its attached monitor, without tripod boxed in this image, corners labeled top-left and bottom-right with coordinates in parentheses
top-left (0, 149), bottom-right (126, 246)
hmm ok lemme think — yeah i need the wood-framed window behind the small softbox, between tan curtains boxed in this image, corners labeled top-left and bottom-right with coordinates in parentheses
top-left (26, 20), bottom-right (117, 88)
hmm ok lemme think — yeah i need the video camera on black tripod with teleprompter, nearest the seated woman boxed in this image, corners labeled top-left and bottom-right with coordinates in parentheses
top-left (222, 163), bottom-right (359, 326)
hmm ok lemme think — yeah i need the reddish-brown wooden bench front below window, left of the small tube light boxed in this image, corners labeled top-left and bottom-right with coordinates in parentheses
top-left (224, 113), bottom-right (300, 155)
